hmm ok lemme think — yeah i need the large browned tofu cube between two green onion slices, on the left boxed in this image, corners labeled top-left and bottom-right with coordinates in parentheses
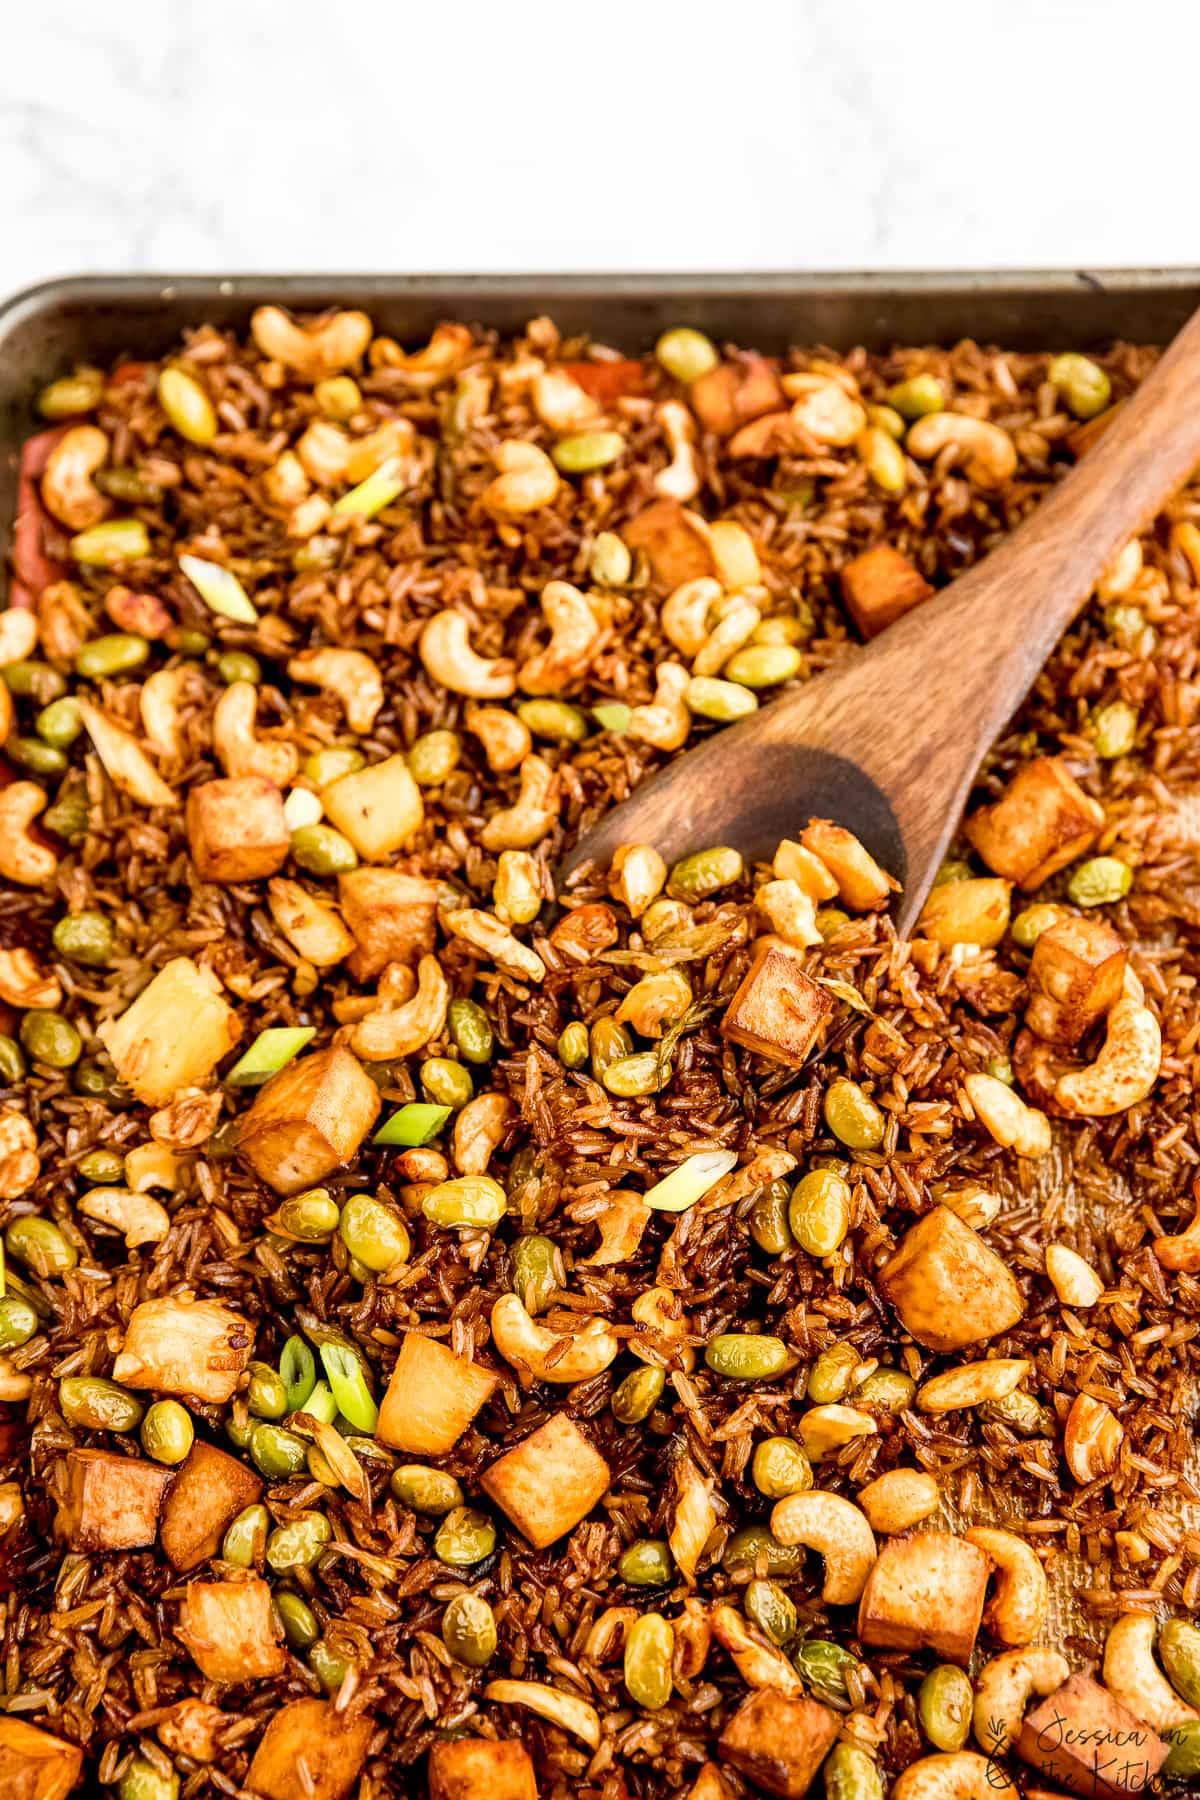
top-left (237, 1044), bottom-right (381, 1193)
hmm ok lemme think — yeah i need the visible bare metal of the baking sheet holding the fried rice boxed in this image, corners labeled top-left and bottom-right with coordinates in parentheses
top-left (0, 268), bottom-right (1200, 1643)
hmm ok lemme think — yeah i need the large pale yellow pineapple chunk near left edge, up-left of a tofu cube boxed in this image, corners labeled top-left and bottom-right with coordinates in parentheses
top-left (99, 956), bottom-right (241, 1107)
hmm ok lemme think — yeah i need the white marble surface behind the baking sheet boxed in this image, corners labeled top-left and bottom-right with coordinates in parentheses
top-left (0, 0), bottom-right (1200, 292)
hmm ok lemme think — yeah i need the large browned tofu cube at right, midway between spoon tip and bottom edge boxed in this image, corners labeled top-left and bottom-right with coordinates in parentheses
top-left (878, 1206), bottom-right (1025, 1352)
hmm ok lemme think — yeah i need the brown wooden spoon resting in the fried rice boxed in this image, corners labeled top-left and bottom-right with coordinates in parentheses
top-left (563, 313), bottom-right (1200, 932)
